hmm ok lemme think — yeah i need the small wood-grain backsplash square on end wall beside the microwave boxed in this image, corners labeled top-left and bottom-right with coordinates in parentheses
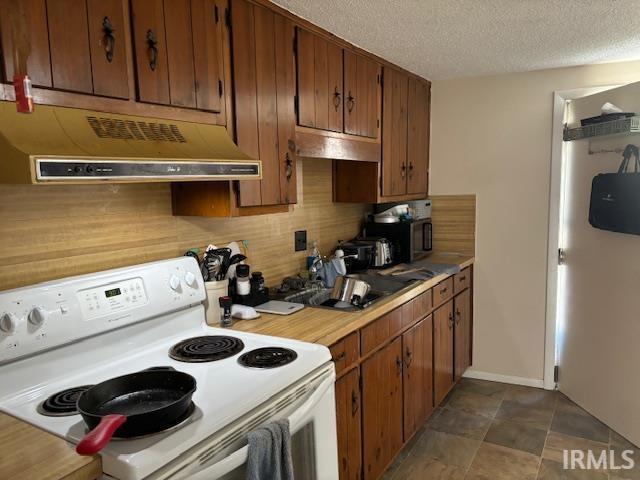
top-left (429, 195), bottom-right (476, 255)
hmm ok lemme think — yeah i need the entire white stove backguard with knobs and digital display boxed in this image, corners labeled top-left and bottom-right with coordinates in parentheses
top-left (0, 257), bottom-right (206, 364)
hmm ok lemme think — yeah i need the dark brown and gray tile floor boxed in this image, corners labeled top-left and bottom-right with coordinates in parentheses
top-left (384, 378), bottom-right (640, 480)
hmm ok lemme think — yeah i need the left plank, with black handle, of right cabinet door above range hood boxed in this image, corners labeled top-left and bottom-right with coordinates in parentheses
top-left (131, 0), bottom-right (170, 105)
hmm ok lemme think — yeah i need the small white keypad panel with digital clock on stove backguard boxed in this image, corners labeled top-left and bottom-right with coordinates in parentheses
top-left (77, 277), bottom-right (148, 320)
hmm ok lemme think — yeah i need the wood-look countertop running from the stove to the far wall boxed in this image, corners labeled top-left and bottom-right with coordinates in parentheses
top-left (232, 253), bottom-right (474, 347)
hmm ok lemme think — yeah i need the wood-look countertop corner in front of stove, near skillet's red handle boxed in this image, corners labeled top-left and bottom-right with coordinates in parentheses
top-left (0, 412), bottom-right (102, 480)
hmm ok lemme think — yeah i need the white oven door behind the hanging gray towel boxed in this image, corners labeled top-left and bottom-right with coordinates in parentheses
top-left (152, 363), bottom-right (338, 480)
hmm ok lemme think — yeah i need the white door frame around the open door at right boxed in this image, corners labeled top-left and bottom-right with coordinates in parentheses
top-left (543, 85), bottom-right (622, 390)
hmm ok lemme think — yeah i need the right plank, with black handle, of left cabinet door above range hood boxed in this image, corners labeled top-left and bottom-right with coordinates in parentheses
top-left (87, 0), bottom-right (129, 98)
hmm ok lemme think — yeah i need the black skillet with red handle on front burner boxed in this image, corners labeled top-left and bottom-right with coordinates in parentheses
top-left (76, 367), bottom-right (196, 455)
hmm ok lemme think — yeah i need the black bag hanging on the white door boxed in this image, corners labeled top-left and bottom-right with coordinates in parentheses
top-left (589, 145), bottom-right (640, 235)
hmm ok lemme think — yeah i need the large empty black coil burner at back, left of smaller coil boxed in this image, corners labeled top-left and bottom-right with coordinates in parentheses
top-left (169, 335), bottom-right (244, 363)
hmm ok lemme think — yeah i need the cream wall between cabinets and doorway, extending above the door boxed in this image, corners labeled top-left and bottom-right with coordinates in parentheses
top-left (429, 62), bottom-right (640, 383)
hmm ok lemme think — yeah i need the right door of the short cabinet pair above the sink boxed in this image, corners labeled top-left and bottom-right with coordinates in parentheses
top-left (344, 50), bottom-right (381, 138)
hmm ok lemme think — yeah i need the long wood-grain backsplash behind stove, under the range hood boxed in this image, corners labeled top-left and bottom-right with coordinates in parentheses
top-left (0, 159), bottom-right (370, 290)
